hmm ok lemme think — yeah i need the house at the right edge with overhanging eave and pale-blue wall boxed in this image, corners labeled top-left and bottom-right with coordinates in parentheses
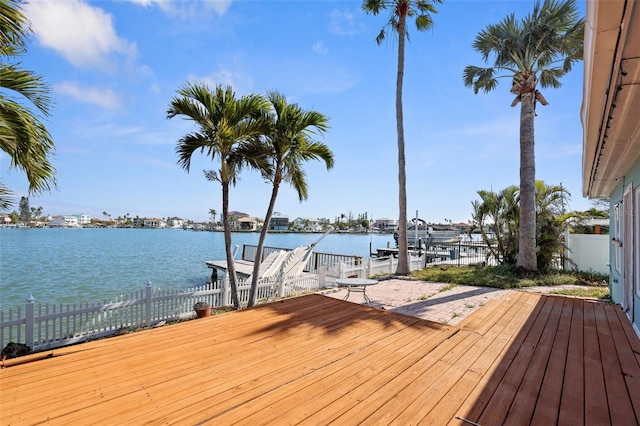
top-left (581, 0), bottom-right (640, 335)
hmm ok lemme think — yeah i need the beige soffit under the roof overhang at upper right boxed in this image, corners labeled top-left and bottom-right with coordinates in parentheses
top-left (583, 1), bottom-right (640, 198)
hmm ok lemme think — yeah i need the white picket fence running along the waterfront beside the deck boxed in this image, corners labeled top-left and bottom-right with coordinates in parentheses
top-left (0, 257), bottom-right (425, 352)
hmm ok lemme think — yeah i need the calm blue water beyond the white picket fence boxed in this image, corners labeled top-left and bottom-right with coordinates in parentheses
top-left (0, 228), bottom-right (394, 310)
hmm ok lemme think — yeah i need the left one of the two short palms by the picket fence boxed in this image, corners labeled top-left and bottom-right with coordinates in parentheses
top-left (167, 83), bottom-right (268, 309)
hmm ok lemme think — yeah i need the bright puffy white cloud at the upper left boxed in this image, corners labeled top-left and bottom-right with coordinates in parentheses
top-left (24, 0), bottom-right (136, 69)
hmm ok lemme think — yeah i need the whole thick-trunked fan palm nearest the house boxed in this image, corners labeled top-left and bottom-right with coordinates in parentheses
top-left (463, 0), bottom-right (584, 271)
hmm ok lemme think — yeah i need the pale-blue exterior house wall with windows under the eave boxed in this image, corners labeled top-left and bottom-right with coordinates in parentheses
top-left (609, 162), bottom-right (640, 333)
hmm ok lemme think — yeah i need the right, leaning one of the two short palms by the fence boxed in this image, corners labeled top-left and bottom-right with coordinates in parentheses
top-left (248, 92), bottom-right (333, 306)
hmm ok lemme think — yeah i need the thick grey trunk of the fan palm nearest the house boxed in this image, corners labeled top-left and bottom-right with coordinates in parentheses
top-left (516, 92), bottom-right (538, 271)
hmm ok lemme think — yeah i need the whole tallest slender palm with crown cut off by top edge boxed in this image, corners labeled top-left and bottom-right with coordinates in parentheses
top-left (362, 0), bottom-right (442, 275)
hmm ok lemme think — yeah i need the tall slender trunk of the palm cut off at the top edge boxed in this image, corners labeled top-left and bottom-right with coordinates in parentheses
top-left (396, 11), bottom-right (409, 275)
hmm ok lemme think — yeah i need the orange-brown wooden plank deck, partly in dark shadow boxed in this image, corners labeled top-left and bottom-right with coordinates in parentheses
top-left (0, 292), bottom-right (640, 425)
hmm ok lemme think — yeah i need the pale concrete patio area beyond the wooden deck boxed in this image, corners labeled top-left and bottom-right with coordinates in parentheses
top-left (325, 278), bottom-right (600, 325)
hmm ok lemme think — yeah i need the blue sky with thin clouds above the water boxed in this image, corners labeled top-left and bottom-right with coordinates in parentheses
top-left (0, 0), bottom-right (591, 222)
